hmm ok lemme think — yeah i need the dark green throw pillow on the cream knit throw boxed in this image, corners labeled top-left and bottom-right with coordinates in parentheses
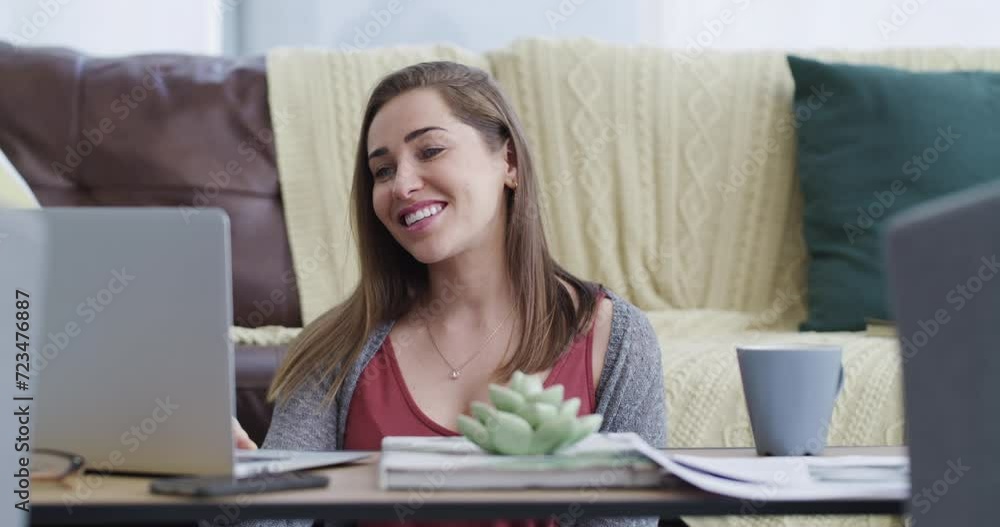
top-left (788, 56), bottom-right (1000, 331)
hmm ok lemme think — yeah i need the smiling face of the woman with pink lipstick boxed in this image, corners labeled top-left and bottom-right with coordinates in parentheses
top-left (368, 88), bottom-right (516, 264)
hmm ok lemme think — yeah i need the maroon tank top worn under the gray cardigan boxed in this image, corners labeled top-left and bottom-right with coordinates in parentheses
top-left (343, 302), bottom-right (602, 527)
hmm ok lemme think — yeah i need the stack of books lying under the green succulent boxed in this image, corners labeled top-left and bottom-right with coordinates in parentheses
top-left (379, 433), bottom-right (664, 490)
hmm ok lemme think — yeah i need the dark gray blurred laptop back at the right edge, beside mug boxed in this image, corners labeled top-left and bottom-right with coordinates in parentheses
top-left (885, 184), bottom-right (1000, 527)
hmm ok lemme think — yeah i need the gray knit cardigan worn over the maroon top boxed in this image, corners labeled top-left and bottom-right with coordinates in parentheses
top-left (240, 289), bottom-right (667, 527)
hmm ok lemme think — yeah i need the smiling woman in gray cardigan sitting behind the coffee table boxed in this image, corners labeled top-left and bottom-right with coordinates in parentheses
top-left (237, 62), bottom-right (666, 523)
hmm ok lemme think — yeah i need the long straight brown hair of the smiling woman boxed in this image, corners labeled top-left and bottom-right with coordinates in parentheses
top-left (268, 62), bottom-right (597, 403)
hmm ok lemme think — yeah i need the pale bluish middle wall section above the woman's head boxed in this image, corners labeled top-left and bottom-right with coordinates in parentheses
top-left (227, 0), bottom-right (660, 54)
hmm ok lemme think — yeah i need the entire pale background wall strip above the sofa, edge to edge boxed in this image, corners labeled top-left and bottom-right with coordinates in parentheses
top-left (0, 0), bottom-right (1000, 55)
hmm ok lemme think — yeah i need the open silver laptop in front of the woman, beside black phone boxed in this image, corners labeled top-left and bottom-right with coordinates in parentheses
top-left (0, 207), bottom-right (365, 477)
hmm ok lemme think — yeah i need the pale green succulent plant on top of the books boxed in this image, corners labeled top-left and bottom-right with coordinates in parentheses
top-left (458, 371), bottom-right (603, 455)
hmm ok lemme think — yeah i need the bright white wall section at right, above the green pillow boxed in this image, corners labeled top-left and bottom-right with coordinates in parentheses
top-left (660, 0), bottom-right (1000, 50)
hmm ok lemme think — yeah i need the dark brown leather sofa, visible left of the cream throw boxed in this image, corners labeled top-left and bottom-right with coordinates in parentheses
top-left (0, 42), bottom-right (294, 443)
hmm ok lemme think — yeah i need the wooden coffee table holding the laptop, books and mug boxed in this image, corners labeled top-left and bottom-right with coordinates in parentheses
top-left (31, 447), bottom-right (906, 525)
